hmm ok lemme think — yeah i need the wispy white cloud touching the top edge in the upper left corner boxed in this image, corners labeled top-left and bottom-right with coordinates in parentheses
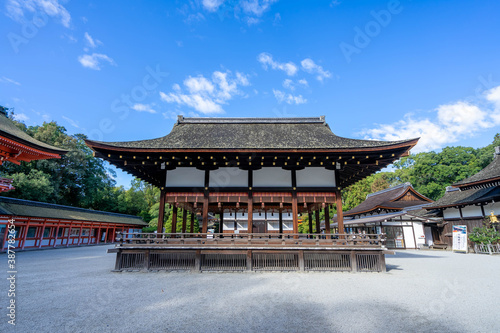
top-left (5, 0), bottom-right (71, 28)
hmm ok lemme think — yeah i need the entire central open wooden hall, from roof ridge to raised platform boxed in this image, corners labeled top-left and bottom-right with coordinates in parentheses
top-left (86, 116), bottom-right (418, 271)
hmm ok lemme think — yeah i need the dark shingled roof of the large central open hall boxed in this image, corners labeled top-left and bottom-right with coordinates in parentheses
top-left (89, 116), bottom-right (418, 149)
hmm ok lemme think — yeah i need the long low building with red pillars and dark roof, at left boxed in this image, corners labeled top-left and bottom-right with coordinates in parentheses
top-left (0, 197), bottom-right (147, 251)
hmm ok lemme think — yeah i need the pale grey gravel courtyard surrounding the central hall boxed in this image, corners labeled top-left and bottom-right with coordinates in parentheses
top-left (0, 246), bottom-right (500, 333)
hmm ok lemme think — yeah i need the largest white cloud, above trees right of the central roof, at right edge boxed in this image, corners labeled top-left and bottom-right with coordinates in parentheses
top-left (362, 86), bottom-right (500, 152)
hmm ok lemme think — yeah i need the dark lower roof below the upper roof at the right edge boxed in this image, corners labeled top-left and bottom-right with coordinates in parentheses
top-left (425, 186), bottom-right (500, 209)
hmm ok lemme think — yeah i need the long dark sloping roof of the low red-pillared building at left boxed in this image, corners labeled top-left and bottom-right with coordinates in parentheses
top-left (0, 197), bottom-right (147, 226)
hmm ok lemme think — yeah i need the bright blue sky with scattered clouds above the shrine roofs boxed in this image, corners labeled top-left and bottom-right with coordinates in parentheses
top-left (0, 0), bottom-right (500, 185)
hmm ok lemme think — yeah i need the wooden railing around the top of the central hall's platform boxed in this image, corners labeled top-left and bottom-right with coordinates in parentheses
top-left (116, 232), bottom-right (386, 248)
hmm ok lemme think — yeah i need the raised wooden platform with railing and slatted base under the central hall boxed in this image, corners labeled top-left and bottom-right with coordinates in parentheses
top-left (108, 234), bottom-right (390, 272)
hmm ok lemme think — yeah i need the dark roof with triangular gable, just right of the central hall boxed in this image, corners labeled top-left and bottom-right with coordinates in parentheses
top-left (344, 183), bottom-right (431, 216)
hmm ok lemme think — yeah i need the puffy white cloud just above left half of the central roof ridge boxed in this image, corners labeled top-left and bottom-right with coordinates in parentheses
top-left (160, 71), bottom-right (250, 114)
